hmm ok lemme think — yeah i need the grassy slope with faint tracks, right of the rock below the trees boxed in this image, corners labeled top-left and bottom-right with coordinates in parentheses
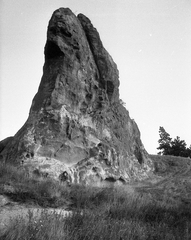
top-left (136, 155), bottom-right (191, 206)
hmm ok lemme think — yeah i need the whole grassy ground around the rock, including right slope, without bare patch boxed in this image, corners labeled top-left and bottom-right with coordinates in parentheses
top-left (0, 155), bottom-right (191, 240)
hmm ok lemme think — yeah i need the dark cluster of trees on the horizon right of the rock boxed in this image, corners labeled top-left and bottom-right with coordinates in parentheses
top-left (157, 127), bottom-right (191, 158)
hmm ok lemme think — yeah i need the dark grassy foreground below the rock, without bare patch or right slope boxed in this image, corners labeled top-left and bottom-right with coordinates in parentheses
top-left (0, 157), bottom-right (191, 240)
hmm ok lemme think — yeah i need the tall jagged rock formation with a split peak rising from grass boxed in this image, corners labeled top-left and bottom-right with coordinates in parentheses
top-left (1, 8), bottom-right (153, 184)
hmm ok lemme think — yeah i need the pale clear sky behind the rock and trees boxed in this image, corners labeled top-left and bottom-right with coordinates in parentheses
top-left (0, 0), bottom-right (191, 153)
